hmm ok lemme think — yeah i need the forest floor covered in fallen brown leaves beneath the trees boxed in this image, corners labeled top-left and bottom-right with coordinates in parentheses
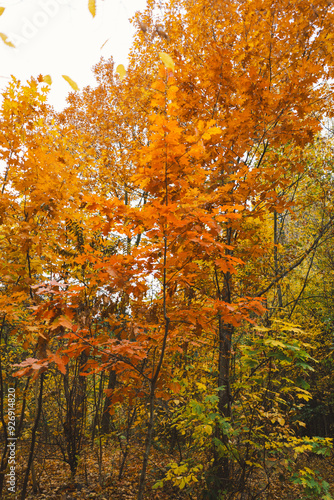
top-left (8, 446), bottom-right (334, 500)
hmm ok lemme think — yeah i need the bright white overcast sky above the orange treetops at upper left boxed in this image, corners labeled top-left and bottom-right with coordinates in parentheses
top-left (0, 0), bottom-right (146, 110)
